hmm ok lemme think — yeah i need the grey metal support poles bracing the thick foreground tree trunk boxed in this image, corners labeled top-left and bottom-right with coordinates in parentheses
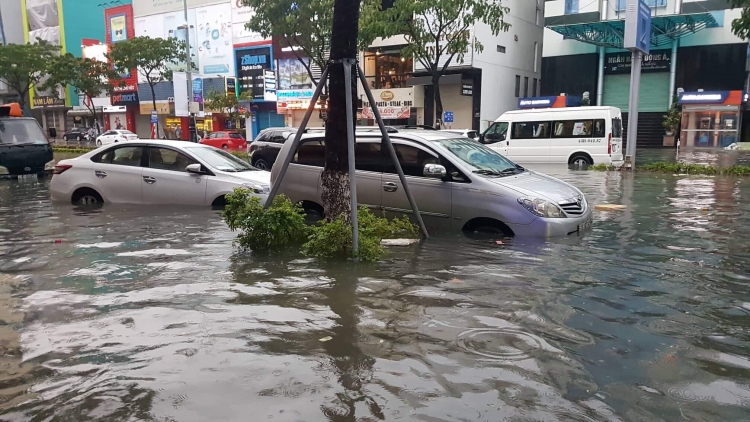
top-left (265, 59), bottom-right (429, 254)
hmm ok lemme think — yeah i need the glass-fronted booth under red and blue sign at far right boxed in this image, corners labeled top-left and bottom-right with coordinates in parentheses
top-left (680, 105), bottom-right (741, 148)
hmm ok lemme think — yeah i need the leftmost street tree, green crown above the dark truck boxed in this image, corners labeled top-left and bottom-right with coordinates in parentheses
top-left (0, 38), bottom-right (60, 110)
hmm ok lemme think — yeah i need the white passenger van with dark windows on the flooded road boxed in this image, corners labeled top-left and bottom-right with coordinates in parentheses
top-left (479, 107), bottom-right (623, 166)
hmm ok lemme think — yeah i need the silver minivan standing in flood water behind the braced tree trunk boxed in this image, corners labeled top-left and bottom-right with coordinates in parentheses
top-left (271, 130), bottom-right (591, 237)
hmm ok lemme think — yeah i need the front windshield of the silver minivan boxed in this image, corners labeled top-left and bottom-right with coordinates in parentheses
top-left (439, 138), bottom-right (524, 176)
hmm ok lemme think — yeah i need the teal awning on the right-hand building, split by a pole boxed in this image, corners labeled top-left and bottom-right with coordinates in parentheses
top-left (547, 12), bottom-right (719, 48)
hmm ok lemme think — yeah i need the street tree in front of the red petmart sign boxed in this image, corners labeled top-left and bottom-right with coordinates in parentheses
top-left (48, 53), bottom-right (122, 129)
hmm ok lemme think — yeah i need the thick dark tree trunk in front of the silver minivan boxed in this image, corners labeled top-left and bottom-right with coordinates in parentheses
top-left (320, 0), bottom-right (360, 220)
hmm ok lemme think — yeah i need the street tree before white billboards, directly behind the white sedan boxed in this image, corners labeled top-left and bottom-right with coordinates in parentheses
top-left (107, 37), bottom-right (187, 134)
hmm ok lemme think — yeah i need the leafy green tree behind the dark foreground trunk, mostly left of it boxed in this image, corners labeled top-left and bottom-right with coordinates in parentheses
top-left (241, 0), bottom-right (380, 85)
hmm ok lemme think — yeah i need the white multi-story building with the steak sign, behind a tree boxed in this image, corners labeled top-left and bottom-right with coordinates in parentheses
top-left (359, 0), bottom-right (544, 129)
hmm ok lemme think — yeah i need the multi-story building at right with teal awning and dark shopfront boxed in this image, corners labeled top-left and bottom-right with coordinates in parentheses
top-left (541, 0), bottom-right (750, 147)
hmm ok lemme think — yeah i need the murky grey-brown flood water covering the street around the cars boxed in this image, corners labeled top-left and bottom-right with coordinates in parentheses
top-left (0, 153), bottom-right (750, 422)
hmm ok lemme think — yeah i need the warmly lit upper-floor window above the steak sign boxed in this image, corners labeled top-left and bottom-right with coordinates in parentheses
top-left (364, 46), bottom-right (414, 89)
